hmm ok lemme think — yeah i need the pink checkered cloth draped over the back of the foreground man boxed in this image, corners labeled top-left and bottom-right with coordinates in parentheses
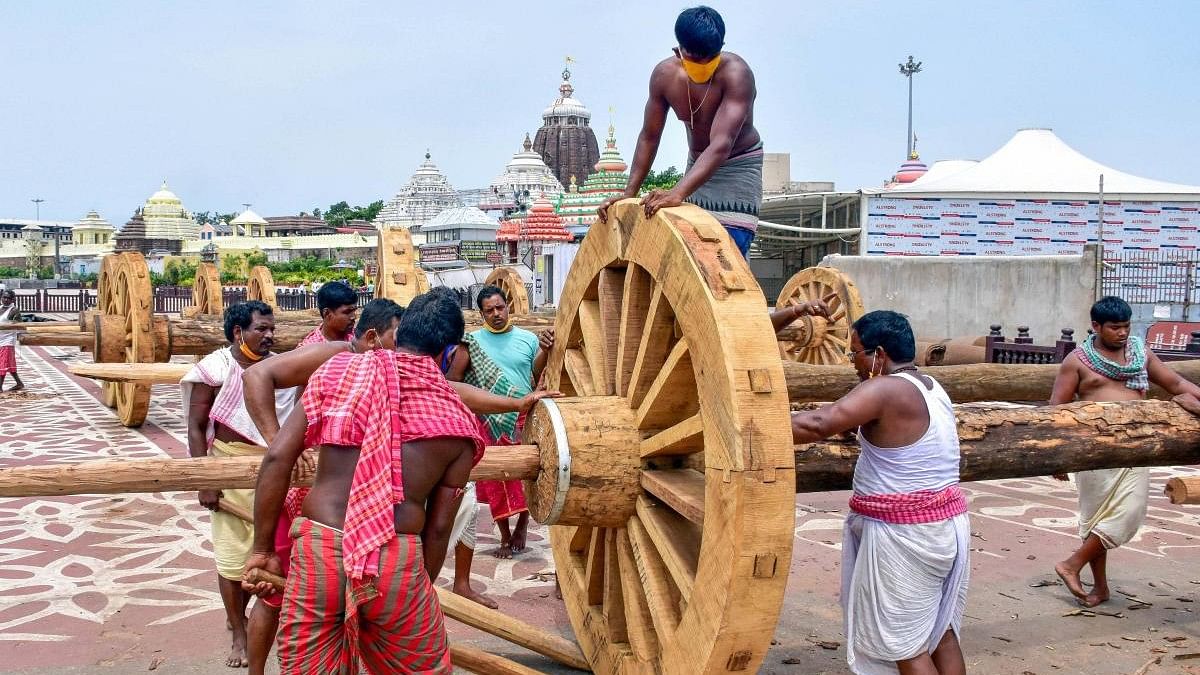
top-left (301, 350), bottom-right (484, 580)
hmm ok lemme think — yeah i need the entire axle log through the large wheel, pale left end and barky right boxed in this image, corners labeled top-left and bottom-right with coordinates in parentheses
top-left (0, 401), bottom-right (1200, 497)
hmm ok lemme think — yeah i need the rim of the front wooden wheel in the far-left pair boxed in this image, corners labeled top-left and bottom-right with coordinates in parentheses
top-left (113, 252), bottom-right (155, 426)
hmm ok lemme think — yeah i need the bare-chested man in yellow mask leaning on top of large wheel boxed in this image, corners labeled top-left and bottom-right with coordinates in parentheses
top-left (599, 6), bottom-right (762, 256)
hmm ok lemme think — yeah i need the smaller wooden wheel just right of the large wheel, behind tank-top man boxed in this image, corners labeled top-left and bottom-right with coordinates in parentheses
top-left (775, 267), bottom-right (865, 365)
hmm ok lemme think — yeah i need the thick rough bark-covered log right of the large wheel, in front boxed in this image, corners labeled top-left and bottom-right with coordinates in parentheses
top-left (796, 398), bottom-right (1200, 492)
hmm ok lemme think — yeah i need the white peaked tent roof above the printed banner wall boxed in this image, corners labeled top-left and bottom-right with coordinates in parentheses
top-left (863, 129), bottom-right (1200, 202)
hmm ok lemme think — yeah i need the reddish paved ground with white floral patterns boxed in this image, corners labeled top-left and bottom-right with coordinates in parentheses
top-left (0, 347), bottom-right (1200, 675)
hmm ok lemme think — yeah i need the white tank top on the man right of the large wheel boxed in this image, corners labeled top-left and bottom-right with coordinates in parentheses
top-left (854, 372), bottom-right (960, 495)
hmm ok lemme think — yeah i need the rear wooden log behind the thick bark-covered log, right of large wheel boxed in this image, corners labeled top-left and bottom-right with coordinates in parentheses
top-left (784, 359), bottom-right (1200, 404)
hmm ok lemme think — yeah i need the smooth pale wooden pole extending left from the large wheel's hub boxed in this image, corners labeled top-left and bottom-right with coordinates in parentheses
top-left (0, 446), bottom-right (541, 497)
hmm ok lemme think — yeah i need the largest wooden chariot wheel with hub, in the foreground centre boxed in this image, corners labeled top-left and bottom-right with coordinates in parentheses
top-left (540, 201), bottom-right (796, 674)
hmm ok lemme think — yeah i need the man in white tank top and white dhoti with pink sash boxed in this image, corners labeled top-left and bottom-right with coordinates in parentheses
top-left (792, 311), bottom-right (971, 675)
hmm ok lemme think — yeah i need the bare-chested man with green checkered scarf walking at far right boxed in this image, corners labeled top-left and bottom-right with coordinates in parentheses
top-left (1050, 295), bottom-right (1200, 607)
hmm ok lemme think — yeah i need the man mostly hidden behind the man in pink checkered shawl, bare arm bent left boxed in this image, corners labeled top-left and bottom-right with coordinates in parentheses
top-left (242, 298), bottom-right (404, 675)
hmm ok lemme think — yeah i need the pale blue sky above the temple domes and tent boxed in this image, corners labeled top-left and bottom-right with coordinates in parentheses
top-left (0, 0), bottom-right (1200, 225)
